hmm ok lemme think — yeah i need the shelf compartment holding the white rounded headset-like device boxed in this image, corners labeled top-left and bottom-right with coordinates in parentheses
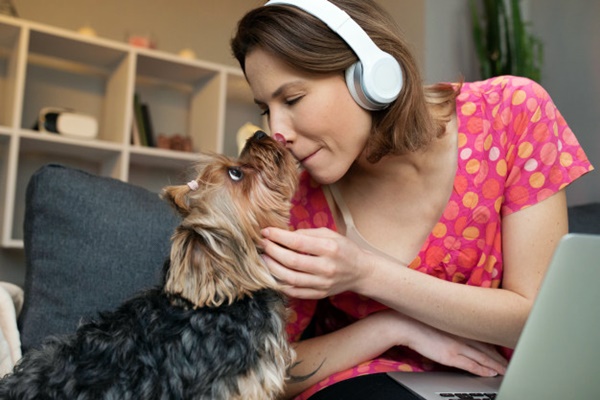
top-left (21, 30), bottom-right (133, 143)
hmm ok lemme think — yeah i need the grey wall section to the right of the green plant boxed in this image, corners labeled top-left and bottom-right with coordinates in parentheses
top-left (529, 0), bottom-right (600, 204)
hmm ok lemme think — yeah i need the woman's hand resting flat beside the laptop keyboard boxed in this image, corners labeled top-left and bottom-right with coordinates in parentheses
top-left (378, 310), bottom-right (508, 376)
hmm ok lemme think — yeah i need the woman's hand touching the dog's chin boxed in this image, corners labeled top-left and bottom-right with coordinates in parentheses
top-left (262, 228), bottom-right (368, 299)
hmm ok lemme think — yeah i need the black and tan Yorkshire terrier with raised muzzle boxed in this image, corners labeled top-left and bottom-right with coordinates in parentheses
top-left (0, 131), bottom-right (298, 400)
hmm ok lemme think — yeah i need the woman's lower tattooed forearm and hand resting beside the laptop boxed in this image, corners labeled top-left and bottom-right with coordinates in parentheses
top-left (286, 310), bottom-right (507, 396)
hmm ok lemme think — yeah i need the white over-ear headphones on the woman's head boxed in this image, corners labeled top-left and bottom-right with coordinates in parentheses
top-left (265, 0), bottom-right (402, 110)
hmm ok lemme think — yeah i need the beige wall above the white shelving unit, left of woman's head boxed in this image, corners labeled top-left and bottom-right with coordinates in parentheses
top-left (13, 0), bottom-right (262, 65)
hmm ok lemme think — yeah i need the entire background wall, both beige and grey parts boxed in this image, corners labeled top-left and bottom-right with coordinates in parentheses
top-left (7, 0), bottom-right (600, 204)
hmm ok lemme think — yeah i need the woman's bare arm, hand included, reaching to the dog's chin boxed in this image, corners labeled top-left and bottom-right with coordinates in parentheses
top-left (264, 191), bottom-right (568, 347)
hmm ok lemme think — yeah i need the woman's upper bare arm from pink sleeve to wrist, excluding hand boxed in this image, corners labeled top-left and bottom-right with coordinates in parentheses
top-left (366, 191), bottom-right (568, 348)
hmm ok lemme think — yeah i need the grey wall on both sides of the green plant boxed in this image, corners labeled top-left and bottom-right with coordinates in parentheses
top-left (424, 0), bottom-right (600, 205)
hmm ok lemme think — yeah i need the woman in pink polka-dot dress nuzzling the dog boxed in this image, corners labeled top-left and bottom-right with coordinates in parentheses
top-left (232, 0), bottom-right (592, 399)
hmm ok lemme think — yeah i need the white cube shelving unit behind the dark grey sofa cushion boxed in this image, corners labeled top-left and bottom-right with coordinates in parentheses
top-left (0, 16), bottom-right (262, 279)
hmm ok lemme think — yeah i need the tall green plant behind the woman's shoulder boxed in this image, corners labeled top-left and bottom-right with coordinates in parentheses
top-left (470, 0), bottom-right (543, 82)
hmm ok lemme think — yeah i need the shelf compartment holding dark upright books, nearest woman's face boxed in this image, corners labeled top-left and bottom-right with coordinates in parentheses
top-left (135, 51), bottom-right (225, 155)
